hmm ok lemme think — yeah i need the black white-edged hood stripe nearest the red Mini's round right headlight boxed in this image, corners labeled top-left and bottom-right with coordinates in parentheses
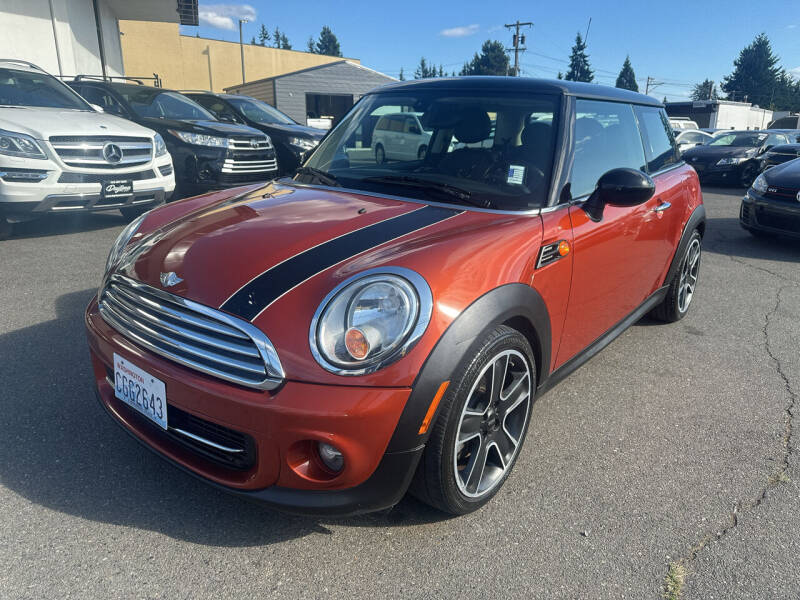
top-left (220, 206), bottom-right (464, 321)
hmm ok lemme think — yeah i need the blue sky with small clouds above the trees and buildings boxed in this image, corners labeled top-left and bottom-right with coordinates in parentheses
top-left (182, 0), bottom-right (800, 100)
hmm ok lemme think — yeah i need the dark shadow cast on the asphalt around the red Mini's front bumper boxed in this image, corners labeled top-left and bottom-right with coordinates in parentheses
top-left (0, 289), bottom-right (447, 546)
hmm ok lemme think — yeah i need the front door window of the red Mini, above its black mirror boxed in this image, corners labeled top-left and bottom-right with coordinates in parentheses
top-left (570, 99), bottom-right (645, 198)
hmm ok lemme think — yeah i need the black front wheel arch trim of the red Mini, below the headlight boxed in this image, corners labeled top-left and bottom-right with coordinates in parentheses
top-left (386, 283), bottom-right (551, 452)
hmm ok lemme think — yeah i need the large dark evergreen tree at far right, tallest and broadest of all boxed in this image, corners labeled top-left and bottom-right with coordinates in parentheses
top-left (720, 33), bottom-right (781, 107)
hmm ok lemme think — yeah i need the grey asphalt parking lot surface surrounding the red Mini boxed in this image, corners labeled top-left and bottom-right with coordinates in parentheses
top-left (0, 189), bottom-right (800, 599)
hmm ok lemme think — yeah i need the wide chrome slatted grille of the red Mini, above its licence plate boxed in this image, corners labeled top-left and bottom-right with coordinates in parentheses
top-left (99, 275), bottom-right (283, 389)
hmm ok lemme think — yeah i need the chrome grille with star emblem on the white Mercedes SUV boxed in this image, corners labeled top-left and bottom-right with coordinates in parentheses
top-left (50, 135), bottom-right (153, 169)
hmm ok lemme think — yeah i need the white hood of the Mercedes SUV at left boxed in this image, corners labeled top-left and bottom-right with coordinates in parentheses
top-left (0, 106), bottom-right (153, 140)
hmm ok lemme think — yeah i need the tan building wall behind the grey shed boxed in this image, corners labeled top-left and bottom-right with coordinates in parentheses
top-left (119, 21), bottom-right (360, 92)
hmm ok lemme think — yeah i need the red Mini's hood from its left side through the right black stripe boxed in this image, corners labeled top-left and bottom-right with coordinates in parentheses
top-left (120, 184), bottom-right (463, 320)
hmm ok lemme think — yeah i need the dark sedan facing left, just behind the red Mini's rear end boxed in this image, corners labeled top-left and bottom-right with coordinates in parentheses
top-left (683, 131), bottom-right (789, 187)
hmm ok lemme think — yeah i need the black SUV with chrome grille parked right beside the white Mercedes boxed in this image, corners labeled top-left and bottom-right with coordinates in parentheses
top-left (68, 78), bottom-right (278, 199)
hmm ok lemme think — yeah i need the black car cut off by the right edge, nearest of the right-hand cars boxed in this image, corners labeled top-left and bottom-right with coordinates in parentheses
top-left (739, 160), bottom-right (800, 238)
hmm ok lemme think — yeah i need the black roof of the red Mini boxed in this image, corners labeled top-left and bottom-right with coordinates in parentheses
top-left (370, 76), bottom-right (663, 106)
